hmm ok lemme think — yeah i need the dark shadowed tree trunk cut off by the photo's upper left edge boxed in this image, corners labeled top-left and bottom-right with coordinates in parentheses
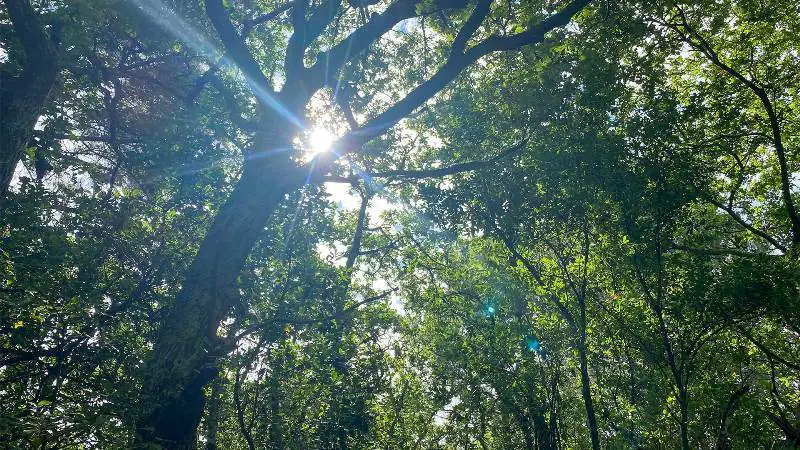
top-left (0, 0), bottom-right (58, 208)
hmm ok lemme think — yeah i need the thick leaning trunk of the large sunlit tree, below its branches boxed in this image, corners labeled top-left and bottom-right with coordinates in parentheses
top-left (137, 122), bottom-right (304, 448)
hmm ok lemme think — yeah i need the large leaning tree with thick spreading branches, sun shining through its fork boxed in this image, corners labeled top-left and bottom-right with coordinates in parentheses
top-left (130, 0), bottom-right (588, 446)
